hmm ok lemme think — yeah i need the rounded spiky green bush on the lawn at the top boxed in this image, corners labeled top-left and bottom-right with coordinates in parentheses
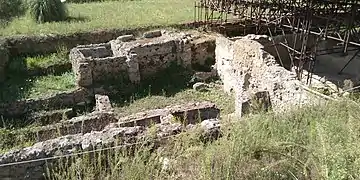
top-left (29, 0), bottom-right (67, 23)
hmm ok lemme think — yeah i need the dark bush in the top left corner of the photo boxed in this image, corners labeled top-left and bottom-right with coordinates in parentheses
top-left (0, 0), bottom-right (25, 22)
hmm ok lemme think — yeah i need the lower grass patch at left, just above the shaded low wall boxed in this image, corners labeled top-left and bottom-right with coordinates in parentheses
top-left (0, 72), bottom-right (76, 102)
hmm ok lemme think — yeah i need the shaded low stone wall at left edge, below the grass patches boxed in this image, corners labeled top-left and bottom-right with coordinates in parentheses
top-left (0, 88), bottom-right (94, 117)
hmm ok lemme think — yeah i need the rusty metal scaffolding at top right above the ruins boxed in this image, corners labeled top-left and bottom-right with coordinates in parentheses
top-left (194, 0), bottom-right (360, 83)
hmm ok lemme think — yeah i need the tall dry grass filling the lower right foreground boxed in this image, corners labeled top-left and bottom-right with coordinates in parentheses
top-left (45, 102), bottom-right (360, 180)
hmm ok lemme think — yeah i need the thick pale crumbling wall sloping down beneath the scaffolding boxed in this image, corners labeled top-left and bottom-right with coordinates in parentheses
top-left (215, 35), bottom-right (319, 116)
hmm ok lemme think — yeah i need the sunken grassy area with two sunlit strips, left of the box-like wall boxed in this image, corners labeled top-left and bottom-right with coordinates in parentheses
top-left (0, 52), bottom-right (75, 102)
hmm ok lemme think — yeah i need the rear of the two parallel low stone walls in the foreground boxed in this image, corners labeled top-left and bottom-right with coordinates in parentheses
top-left (35, 102), bottom-right (220, 141)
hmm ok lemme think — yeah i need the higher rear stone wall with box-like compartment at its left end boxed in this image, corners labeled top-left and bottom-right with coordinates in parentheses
top-left (70, 31), bottom-right (215, 87)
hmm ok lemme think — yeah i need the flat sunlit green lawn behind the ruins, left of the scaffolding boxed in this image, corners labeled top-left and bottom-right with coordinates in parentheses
top-left (0, 0), bottom-right (193, 36)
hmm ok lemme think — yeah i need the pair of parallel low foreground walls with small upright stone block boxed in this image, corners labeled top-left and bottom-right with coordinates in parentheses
top-left (0, 99), bottom-right (220, 179)
